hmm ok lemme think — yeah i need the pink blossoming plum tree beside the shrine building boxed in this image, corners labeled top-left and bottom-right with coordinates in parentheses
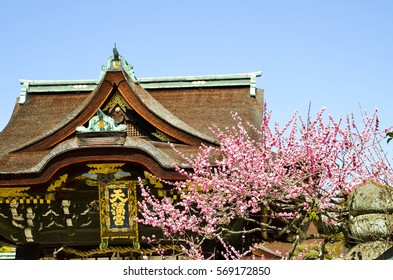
top-left (138, 105), bottom-right (393, 259)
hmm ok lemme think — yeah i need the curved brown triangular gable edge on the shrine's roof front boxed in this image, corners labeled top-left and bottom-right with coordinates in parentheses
top-left (13, 71), bottom-right (218, 154)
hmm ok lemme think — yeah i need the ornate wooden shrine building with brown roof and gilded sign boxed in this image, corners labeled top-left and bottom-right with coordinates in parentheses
top-left (0, 49), bottom-right (263, 259)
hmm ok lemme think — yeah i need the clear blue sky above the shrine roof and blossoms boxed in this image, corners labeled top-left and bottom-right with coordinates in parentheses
top-left (0, 0), bottom-right (393, 133)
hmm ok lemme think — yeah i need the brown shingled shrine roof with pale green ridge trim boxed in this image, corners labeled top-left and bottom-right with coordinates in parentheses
top-left (0, 56), bottom-right (263, 182)
